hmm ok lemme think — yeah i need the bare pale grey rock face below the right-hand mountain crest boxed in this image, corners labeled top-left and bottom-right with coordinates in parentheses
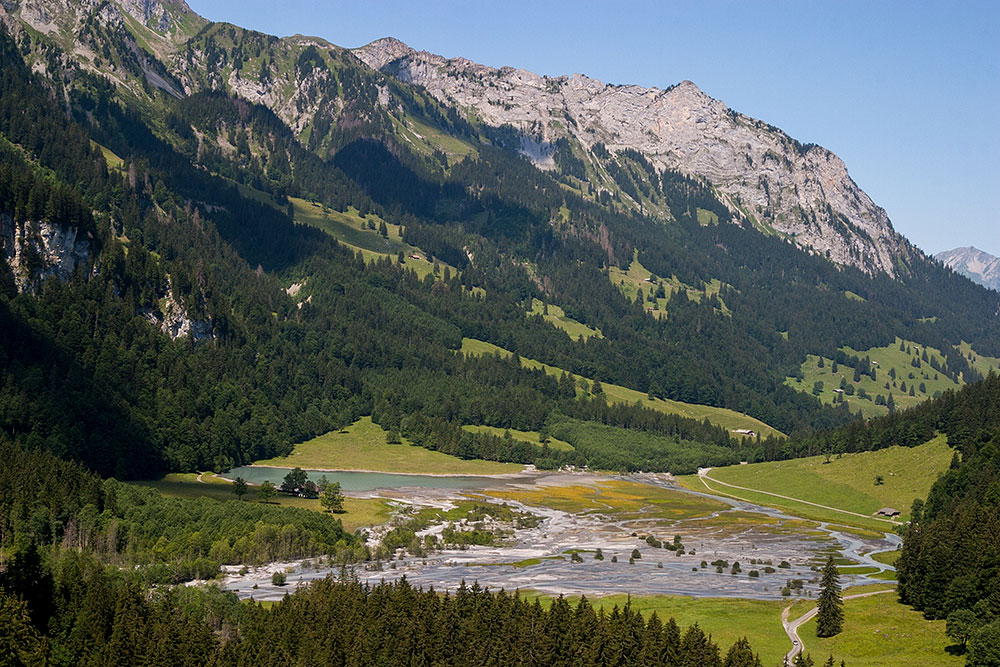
top-left (354, 38), bottom-right (912, 275)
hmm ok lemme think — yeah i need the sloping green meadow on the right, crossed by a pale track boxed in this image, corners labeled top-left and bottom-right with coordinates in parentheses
top-left (679, 435), bottom-right (952, 530)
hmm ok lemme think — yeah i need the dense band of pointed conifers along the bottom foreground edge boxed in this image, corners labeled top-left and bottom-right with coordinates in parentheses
top-left (0, 553), bottom-right (780, 667)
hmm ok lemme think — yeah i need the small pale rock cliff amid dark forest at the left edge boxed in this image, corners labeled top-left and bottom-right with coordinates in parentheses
top-left (0, 218), bottom-right (92, 293)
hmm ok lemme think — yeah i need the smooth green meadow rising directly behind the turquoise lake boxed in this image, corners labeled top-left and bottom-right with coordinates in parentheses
top-left (256, 417), bottom-right (524, 475)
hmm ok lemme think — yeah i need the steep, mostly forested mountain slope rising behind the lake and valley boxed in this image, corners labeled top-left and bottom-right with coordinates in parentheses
top-left (0, 1), bottom-right (1000, 476)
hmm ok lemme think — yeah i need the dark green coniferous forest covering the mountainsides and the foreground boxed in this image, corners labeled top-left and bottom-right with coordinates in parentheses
top-left (0, 3), bottom-right (1000, 667)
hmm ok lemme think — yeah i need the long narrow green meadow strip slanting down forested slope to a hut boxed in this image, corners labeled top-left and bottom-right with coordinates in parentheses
top-left (462, 338), bottom-right (781, 436)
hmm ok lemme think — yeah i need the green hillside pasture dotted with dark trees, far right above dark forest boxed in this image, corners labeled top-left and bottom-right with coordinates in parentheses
top-left (785, 338), bottom-right (968, 417)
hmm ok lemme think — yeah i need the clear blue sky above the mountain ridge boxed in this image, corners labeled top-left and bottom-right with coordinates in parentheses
top-left (189, 0), bottom-right (1000, 255)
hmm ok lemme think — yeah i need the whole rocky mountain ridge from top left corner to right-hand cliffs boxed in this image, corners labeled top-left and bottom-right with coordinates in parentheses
top-left (0, 0), bottom-right (920, 277)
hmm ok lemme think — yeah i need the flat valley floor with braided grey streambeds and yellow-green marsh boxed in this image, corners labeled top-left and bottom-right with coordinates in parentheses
top-left (155, 430), bottom-right (961, 666)
